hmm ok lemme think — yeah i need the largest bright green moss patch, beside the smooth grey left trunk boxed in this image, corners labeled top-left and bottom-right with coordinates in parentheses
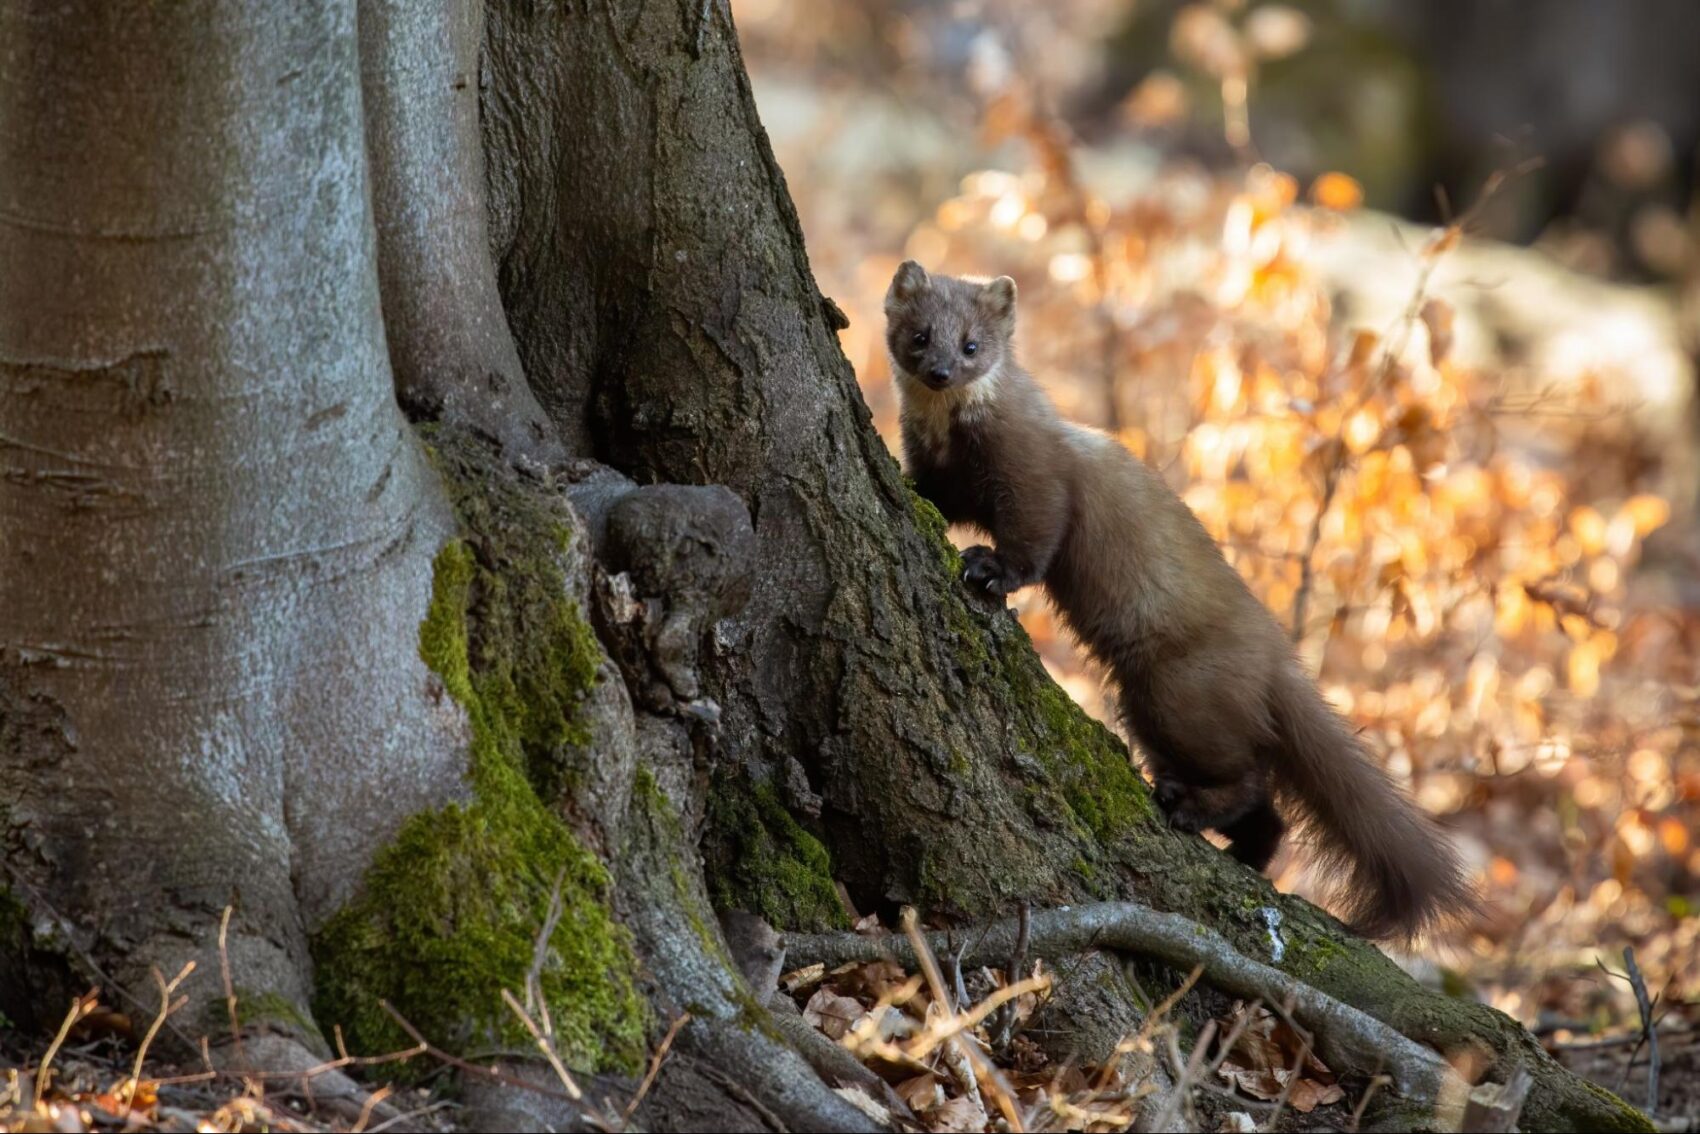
top-left (313, 542), bottom-right (646, 1071)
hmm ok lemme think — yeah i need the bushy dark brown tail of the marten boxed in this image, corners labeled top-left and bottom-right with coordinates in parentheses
top-left (1273, 666), bottom-right (1476, 940)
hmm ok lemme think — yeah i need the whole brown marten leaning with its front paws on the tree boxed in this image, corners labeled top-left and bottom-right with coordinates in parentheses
top-left (886, 260), bottom-right (1474, 938)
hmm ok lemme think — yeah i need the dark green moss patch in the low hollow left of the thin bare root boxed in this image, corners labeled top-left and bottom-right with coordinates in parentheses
top-left (709, 777), bottom-right (850, 932)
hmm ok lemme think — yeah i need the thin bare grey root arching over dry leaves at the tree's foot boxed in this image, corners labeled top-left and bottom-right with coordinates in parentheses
top-left (787, 901), bottom-right (1467, 1103)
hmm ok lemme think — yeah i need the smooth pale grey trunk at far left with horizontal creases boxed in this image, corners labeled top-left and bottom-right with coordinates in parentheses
top-left (0, 0), bottom-right (462, 1034)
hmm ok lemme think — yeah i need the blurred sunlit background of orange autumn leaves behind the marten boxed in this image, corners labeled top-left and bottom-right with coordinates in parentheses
top-left (733, 0), bottom-right (1700, 1101)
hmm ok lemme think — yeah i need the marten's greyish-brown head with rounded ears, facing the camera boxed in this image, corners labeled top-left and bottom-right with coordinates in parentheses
top-left (886, 260), bottom-right (1015, 391)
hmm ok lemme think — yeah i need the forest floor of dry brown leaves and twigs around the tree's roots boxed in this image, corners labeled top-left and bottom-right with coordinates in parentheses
top-left (0, 925), bottom-right (1700, 1134)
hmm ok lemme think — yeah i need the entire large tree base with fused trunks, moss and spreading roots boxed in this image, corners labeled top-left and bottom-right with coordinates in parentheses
top-left (0, 0), bottom-right (1639, 1129)
